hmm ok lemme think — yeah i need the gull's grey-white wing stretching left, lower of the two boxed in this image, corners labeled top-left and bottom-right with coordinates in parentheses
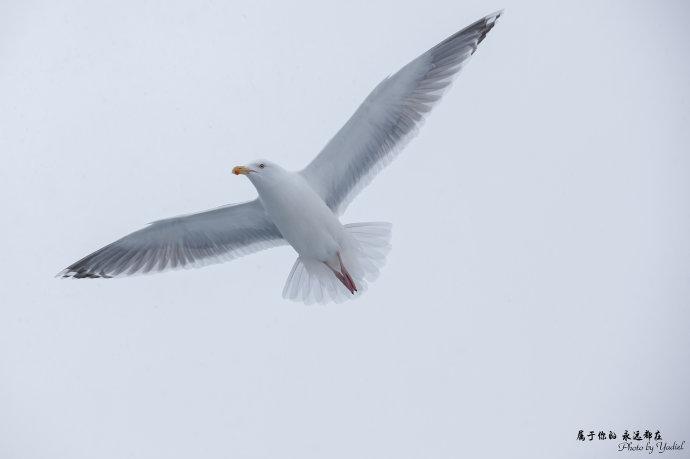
top-left (58, 199), bottom-right (285, 279)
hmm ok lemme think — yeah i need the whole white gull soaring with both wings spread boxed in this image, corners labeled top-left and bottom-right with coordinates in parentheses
top-left (57, 10), bottom-right (503, 304)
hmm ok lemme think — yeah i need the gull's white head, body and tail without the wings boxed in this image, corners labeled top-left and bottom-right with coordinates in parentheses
top-left (239, 160), bottom-right (390, 301)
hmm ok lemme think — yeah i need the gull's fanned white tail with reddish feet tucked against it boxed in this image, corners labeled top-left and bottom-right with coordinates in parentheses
top-left (283, 222), bottom-right (391, 304)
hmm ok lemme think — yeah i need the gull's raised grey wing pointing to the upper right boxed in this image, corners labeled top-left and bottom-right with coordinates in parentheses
top-left (301, 11), bottom-right (501, 214)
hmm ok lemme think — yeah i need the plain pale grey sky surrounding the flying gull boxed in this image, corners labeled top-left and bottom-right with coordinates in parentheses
top-left (0, 0), bottom-right (690, 459)
